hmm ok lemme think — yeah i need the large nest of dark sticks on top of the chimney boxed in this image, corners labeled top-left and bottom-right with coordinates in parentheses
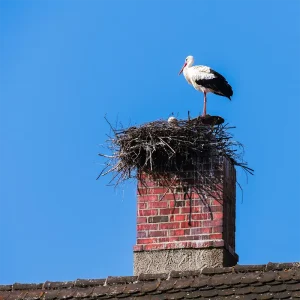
top-left (98, 118), bottom-right (253, 185)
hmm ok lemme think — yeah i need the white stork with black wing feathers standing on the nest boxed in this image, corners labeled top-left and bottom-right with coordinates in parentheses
top-left (179, 55), bottom-right (233, 117)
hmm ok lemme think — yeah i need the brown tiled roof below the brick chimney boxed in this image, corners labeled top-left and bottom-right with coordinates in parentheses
top-left (0, 263), bottom-right (300, 300)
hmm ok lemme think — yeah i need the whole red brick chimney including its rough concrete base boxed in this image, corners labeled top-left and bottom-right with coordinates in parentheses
top-left (134, 157), bottom-right (238, 275)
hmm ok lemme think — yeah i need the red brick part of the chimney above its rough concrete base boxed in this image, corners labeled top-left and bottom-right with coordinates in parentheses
top-left (134, 158), bottom-right (235, 253)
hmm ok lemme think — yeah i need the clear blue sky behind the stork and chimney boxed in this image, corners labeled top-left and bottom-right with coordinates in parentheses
top-left (0, 0), bottom-right (300, 284)
